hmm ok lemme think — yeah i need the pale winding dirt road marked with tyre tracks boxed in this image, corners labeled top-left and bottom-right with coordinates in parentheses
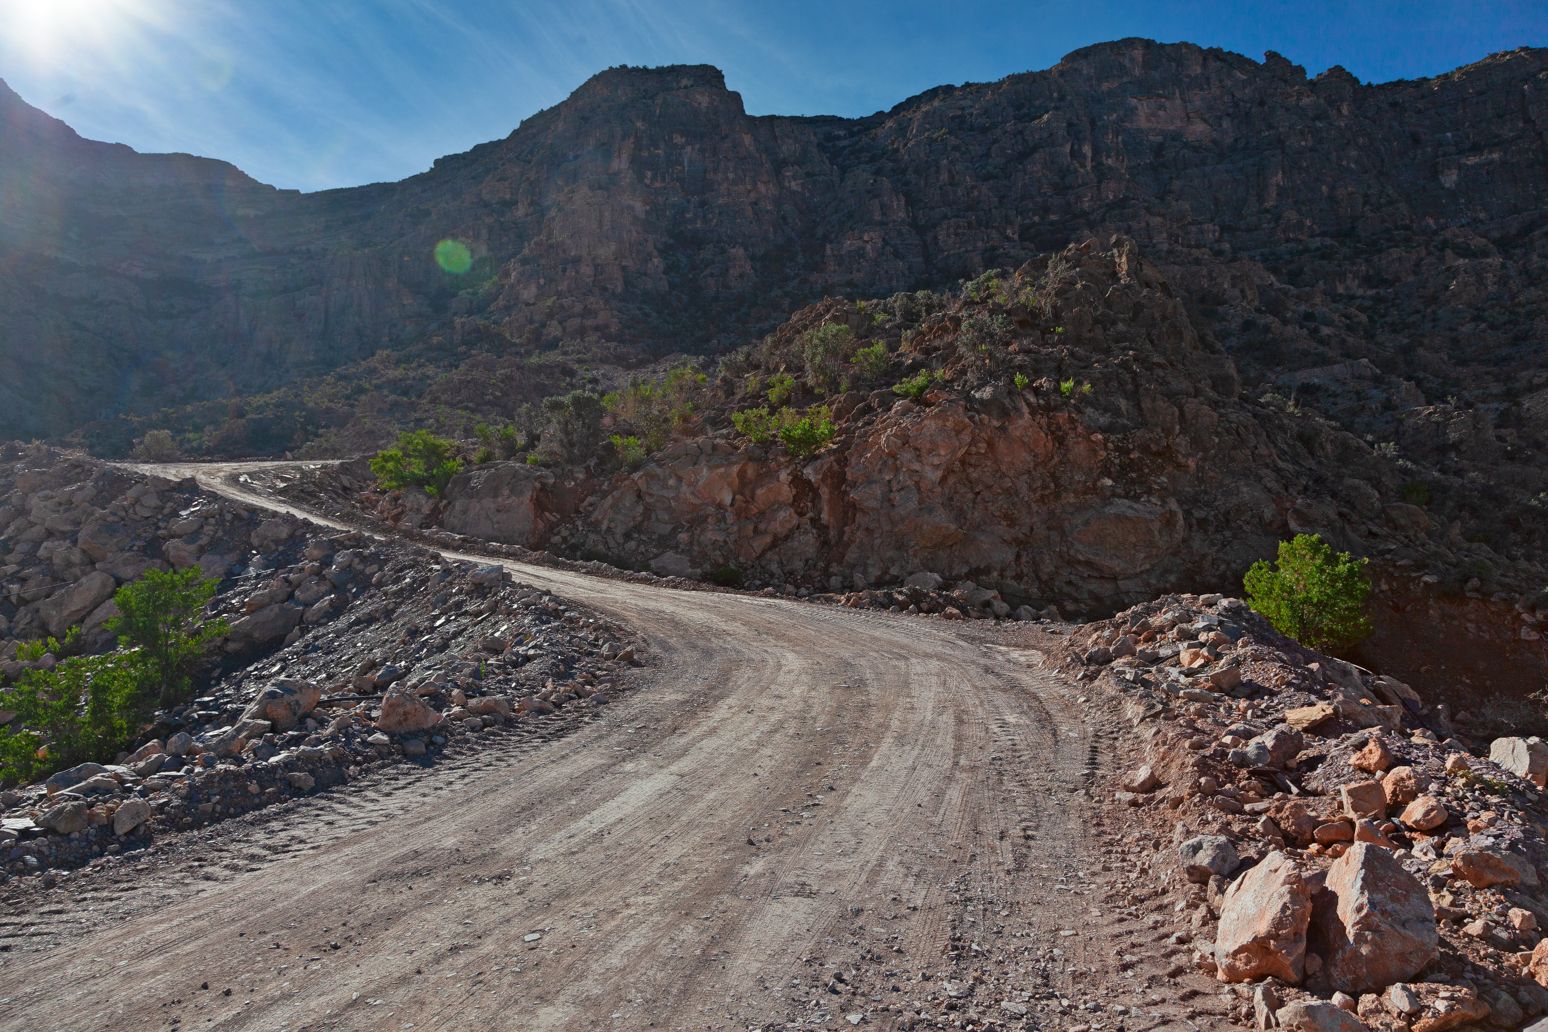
top-left (0, 470), bottom-right (1220, 1030)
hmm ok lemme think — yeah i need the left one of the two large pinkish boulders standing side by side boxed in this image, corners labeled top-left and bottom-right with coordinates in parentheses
top-left (1215, 851), bottom-right (1311, 984)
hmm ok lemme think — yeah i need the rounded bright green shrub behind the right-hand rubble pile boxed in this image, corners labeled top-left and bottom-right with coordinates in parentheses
top-left (1241, 534), bottom-right (1372, 651)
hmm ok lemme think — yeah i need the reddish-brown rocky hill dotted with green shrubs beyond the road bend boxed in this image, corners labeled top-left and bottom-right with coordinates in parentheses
top-left (298, 240), bottom-right (1548, 711)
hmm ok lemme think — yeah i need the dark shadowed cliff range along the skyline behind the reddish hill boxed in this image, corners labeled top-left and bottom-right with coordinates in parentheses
top-left (0, 40), bottom-right (1548, 454)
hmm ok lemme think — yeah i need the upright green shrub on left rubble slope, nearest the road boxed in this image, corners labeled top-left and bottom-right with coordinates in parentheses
top-left (107, 566), bottom-right (231, 706)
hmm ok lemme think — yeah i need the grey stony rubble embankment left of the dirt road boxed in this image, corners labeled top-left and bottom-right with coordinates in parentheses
top-left (0, 447), bottom-right (638, 877)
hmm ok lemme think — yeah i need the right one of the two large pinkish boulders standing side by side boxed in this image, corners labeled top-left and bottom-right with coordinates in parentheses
top-left (1311, 842), bottom-right (1440, 993)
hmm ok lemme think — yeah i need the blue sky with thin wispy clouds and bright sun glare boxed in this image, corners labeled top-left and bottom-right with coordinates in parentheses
top-left (0, 0), bottom-right (1548, 190)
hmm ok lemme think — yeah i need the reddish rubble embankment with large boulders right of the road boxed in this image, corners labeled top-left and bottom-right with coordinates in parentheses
top-left (1063, 596), bottom-right (1548, 1032)
